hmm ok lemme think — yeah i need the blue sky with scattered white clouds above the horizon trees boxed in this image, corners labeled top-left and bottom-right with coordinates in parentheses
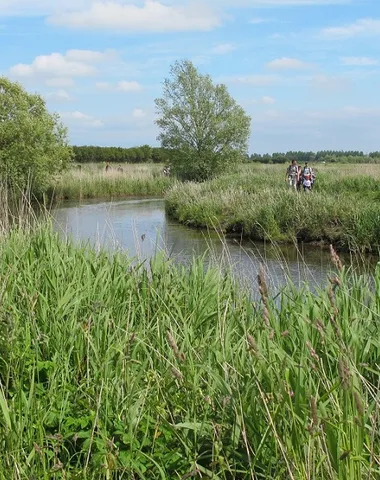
top-left (0, 0), bottom-right (380, 153)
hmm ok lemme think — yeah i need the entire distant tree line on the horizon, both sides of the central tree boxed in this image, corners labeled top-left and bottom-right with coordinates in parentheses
top-left (73, 145), bottom-right (380, 164)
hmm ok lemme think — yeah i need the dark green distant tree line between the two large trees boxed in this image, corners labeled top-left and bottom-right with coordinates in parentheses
top-left (73, 145), bottom-right (174, 163)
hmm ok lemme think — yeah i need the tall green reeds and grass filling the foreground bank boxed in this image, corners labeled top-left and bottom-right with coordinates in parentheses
top-left (0, 227), bottom-right (380, 480)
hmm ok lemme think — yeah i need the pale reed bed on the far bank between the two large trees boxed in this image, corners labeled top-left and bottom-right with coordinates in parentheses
top-left (47, 164), bottom-right (173, 200)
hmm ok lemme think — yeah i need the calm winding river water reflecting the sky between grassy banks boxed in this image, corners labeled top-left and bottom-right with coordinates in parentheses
top-left (53, 198), bottom-right (374, 290)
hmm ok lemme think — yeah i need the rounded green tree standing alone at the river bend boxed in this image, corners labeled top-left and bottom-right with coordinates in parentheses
top-left (155, 60), bottom-right (251, 180)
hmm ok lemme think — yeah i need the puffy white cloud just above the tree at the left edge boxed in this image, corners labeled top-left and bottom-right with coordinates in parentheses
top-left (10, 50), bottom-right (113, 78)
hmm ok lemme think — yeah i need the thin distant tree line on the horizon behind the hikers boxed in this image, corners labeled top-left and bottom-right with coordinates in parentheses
top-left (247, 150), bottom-right (380, 163)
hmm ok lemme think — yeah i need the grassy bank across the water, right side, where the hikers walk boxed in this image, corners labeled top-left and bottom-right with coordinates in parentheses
top-left (166, 165), bottom-right (380, 252)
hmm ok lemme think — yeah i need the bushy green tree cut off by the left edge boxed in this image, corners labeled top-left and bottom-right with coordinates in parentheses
top-left (0, 77), bottom-right (72, 193)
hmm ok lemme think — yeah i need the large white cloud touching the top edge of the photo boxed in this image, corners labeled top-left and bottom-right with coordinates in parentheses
top-left (48, 0), bottom-right (221, 32)
